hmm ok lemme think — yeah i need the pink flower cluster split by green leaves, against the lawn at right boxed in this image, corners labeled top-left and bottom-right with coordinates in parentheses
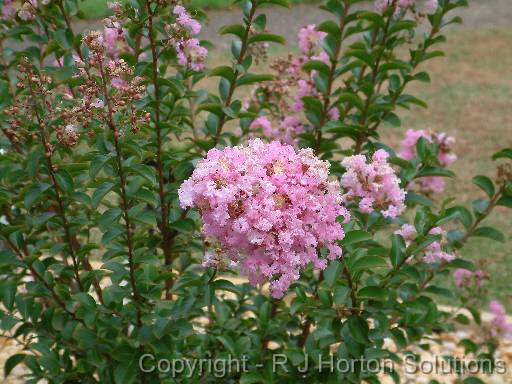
top-left (399, 129), bottom-right (457, 193)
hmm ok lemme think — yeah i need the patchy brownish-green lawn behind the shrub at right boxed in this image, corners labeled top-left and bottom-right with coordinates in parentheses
top-left (382, 28), bottom-right (512, 310)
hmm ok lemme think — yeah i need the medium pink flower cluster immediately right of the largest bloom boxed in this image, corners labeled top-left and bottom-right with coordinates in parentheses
top-left (341, 149), bottom-right (405, 218)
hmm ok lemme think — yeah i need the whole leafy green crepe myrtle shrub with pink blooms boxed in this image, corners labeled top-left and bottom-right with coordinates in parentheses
top-left (0, 0), bottom-right (512, 384)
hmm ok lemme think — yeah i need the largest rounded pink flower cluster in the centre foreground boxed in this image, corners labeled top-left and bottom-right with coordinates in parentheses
top-left (178, 139), bottom-right (350, 297)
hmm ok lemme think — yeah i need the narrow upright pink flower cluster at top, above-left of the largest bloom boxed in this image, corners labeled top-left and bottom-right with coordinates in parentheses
top-left (166, 5), bottom-right (208, 72)
